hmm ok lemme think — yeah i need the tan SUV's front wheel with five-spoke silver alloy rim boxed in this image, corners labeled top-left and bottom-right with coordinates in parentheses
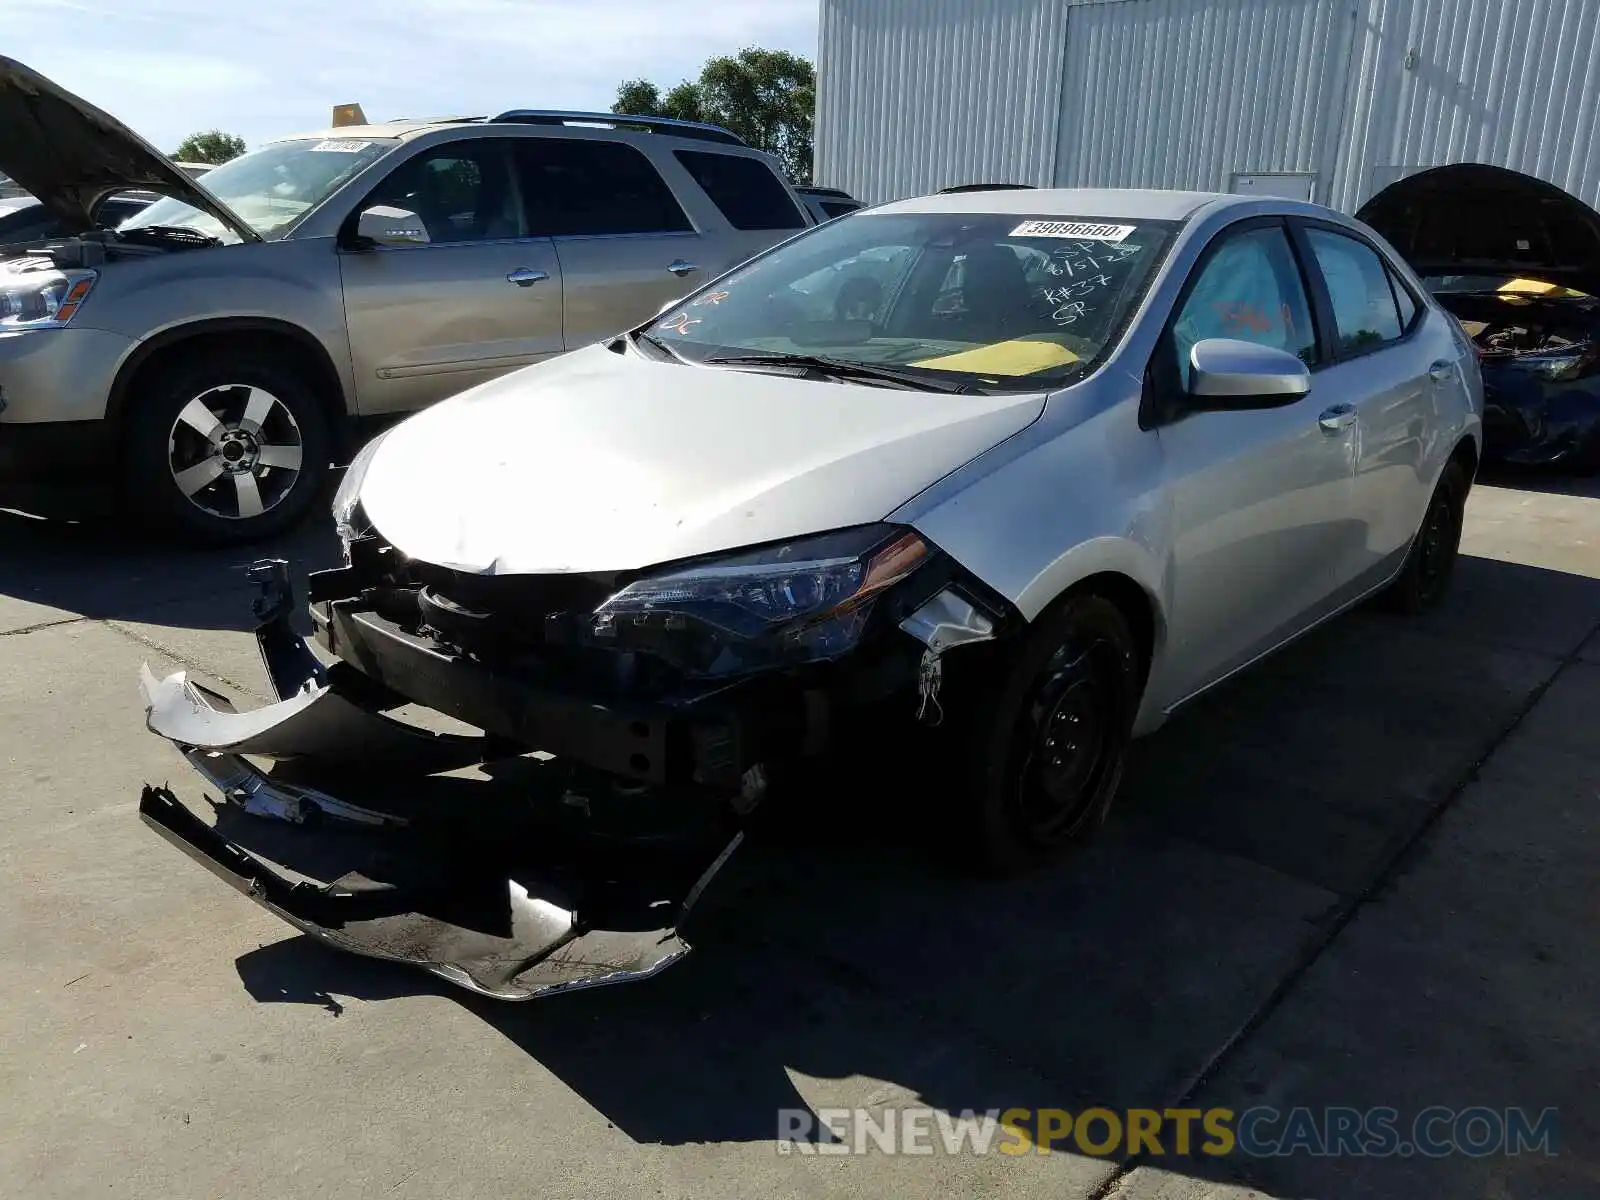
top-left (125, 350), bottom-right (331, 546)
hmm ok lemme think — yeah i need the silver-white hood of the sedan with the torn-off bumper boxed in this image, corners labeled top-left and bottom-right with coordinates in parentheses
top-left (360, 346), bottom-right (1045, 574)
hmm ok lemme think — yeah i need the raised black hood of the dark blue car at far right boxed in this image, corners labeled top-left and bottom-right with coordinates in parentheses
top-left (1355, 163), bottom-right (1600, 296)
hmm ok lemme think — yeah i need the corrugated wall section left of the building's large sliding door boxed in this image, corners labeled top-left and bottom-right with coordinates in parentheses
top-left (813, 0), bottom-right (1066, 202)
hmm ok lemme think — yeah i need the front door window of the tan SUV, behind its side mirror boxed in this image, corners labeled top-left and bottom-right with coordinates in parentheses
top-left (363, 138), bottom-right (522, 245)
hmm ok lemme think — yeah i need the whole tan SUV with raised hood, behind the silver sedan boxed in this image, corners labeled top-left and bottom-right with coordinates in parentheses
top-left (0, 58), bottom-right (813, 541)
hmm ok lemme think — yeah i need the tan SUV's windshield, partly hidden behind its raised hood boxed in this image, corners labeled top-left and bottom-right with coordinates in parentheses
top-left (118, 138), bottom-right (395, 242)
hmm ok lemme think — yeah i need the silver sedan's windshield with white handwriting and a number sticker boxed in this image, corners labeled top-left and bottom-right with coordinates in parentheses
top-left (648, 213), bottom-right (1173, 390)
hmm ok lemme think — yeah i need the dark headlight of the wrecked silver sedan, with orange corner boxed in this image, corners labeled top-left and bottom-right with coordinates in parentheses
top-left (590, 525), bottom-right (933, 677)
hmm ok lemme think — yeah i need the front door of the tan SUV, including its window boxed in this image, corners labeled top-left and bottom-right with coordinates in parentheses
top-left (339, 138), bottom-right (562, 414)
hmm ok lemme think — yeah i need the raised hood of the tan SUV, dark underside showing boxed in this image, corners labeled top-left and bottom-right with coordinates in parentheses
top-left (0, 56), bottom-right (261, 242)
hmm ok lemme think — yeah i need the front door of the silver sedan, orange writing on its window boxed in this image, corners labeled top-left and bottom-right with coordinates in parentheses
top-left (1150, 219), bottom-right (1354, 707)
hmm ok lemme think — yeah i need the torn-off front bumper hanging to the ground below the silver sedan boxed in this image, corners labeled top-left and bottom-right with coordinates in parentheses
top-left (139, 565), bottom-right (742, 1000)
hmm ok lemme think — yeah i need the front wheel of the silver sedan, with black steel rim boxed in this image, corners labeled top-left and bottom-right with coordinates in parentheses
top-left (952, 592), bottom-right (1144, 874)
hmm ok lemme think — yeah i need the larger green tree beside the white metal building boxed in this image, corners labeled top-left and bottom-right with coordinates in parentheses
top-left (611, 46), bottom-right (816, 184)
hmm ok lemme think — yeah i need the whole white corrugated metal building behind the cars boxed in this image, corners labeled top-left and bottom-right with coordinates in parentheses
top-left (816, 0), bottom-right (1600, 211)
